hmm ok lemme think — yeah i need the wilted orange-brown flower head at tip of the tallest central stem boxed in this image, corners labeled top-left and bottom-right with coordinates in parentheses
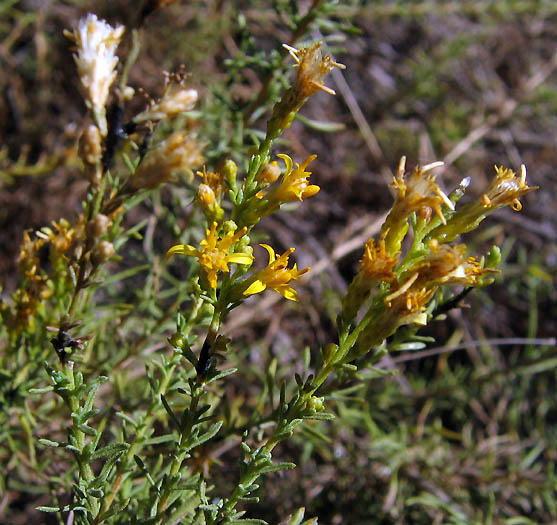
top-left (283, 42), bottom-right (345, 99)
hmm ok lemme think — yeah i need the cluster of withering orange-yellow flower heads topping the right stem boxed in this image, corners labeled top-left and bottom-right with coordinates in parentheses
top-left (341, 159), bottom-right (535, 359)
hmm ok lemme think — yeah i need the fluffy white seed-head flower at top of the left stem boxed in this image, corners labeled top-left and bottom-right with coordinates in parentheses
top-left (64, 13), bottom-right (124, 117)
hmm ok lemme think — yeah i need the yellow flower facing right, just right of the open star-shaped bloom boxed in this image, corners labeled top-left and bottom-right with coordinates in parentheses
top-left (243, 244), bottom-right (310, 301)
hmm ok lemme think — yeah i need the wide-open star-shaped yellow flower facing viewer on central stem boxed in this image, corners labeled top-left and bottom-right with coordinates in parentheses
top-left (166, 222), bottom-right (253, 289)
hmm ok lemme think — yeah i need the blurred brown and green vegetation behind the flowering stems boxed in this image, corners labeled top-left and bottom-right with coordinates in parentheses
top-left (0, 0), bottom-right (557, 524)
